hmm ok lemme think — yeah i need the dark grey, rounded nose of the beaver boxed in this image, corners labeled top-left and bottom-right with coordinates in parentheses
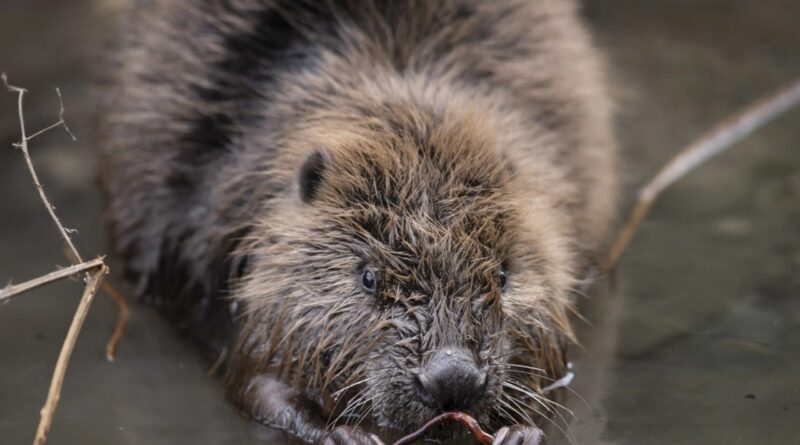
top-left (414, 349), bottom-right (486, 411)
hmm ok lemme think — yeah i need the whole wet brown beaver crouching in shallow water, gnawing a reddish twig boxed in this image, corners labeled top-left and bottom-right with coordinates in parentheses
top-left (98, 0), bottom-right (616, 445)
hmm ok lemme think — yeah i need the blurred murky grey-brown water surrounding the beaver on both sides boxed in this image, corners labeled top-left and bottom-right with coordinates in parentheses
top-left (0, 0), bottom-right (800, 445)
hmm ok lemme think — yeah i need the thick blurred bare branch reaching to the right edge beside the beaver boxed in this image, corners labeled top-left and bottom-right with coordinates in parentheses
top-left (600, 80), bottom-right (800, 273)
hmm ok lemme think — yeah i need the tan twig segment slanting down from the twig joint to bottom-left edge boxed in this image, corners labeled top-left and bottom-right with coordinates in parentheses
top-left (33, 265), bottom-right (108, 445)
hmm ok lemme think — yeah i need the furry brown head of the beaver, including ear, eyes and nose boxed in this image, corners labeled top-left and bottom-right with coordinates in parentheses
top-left (231, 102), bottom-right (571, 436)
